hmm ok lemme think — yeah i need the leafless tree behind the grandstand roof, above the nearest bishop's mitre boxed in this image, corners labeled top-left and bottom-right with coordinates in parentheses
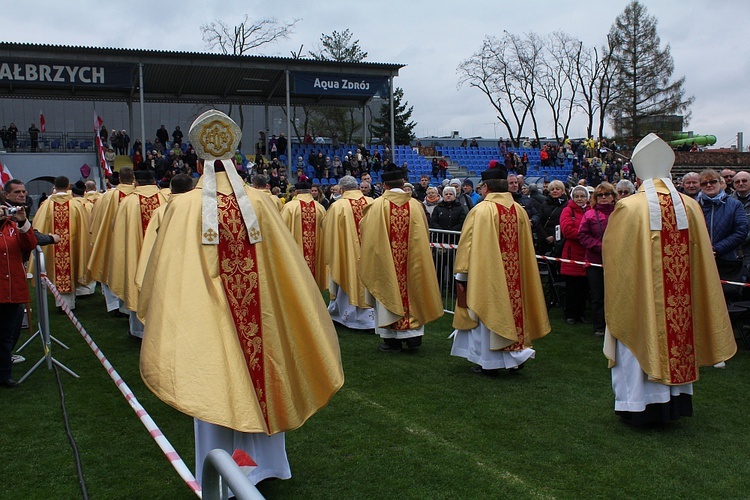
top-left (201, 14), bottom-right (301, 144)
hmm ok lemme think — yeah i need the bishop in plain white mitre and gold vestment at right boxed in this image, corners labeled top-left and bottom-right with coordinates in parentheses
top-left (602, 134), bottom-right (737, 425)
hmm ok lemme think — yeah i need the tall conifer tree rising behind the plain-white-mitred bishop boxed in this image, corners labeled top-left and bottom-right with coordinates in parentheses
top-left (609, 0), bottom-right (695, 143)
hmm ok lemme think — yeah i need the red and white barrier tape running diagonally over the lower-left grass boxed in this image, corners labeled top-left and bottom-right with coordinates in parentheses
top-left (41, 274), bottom-right (202, 498)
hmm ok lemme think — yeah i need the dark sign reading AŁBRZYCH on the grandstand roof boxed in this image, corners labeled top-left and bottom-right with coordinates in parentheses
top-left (0, 60), bottom-right (134, 88)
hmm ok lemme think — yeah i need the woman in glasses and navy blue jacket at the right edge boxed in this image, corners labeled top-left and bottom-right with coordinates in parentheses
top-left (698, 170), bottom-right (748, 295)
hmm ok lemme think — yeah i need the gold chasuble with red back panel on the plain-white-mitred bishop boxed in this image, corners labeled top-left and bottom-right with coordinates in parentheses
top-left (602, 179), bottom-right (737, 385)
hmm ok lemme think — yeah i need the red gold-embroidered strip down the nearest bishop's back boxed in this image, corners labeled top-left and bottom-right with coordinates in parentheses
top-left (217, 194), bottom-right (268, 427)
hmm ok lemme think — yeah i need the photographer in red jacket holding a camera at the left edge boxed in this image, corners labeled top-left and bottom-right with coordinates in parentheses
top-left (0, 189), bottom-right (37, 388)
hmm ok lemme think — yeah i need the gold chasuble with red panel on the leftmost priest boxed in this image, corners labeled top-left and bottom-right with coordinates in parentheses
top-left (34, 194), bottom-right (91, 293)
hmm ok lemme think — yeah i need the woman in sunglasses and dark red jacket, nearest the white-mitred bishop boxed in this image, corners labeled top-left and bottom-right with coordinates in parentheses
top-left (578, 182), bottom-right (617, 335)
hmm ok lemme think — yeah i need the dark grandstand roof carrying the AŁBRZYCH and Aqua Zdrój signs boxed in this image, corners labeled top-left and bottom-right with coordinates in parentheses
top-left (0, 42), bottom-right (405, 106)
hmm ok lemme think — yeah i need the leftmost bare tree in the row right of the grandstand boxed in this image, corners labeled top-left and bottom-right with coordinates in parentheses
top-left (457, 31), bottom-right (541, 146)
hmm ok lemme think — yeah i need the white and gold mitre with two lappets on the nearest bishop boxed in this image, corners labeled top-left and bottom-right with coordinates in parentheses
top-left (188, 109), bottom-right (262, 245)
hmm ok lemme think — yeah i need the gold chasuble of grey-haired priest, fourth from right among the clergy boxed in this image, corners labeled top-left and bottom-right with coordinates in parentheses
top-left (323, 190), bottom-right (373, 309)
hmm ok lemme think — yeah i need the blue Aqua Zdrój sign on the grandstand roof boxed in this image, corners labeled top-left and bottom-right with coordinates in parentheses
top-left (292, 72), bottom-right (389, 97)
